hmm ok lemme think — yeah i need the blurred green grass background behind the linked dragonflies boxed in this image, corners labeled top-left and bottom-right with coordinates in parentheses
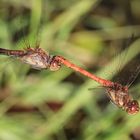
top-left (0, 0), bottom-right (140, 140)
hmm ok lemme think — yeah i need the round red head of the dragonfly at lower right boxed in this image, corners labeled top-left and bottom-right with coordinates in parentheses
top-left (126, 100), bottom-right (140, 114)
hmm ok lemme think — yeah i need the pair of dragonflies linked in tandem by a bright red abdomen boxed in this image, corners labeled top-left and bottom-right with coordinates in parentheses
top-left (0, 46), bottom-right (140, 114)
